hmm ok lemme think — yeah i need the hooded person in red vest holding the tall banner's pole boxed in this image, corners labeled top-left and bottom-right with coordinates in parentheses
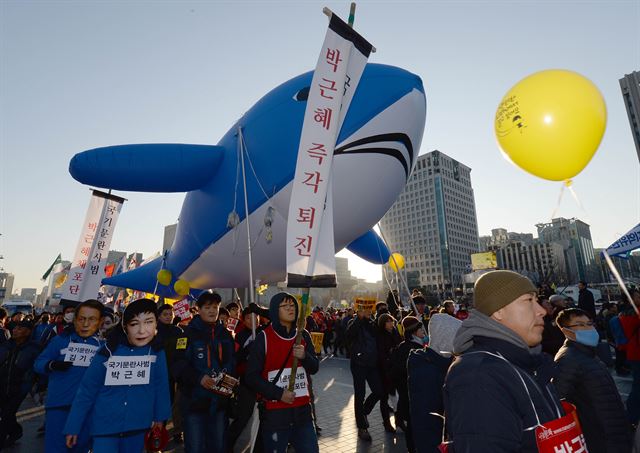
top-left (245, 293), bottom-right (319, 453)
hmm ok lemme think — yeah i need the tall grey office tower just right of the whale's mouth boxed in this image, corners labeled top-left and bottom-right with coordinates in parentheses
top-left (380, 150), bottom-right (478, 291)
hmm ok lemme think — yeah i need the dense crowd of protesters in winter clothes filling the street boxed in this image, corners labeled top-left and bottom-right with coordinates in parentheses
top-left (0, 271), bottom-right (640, 453)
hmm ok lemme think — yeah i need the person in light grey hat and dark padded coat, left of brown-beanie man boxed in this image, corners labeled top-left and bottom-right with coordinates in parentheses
top-left (407, 313), bottom-right (462, 453)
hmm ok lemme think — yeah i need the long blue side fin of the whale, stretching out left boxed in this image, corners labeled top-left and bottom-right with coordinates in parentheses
top-left (69, 143), bottom-right (224, 192)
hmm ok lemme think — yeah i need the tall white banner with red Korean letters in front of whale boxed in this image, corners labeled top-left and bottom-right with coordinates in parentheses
top-left (287, 14), bottom-right (372, 288)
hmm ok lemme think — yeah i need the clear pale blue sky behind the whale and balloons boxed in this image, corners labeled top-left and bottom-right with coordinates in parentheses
top-left (0, 0), bottom-right (640, 294)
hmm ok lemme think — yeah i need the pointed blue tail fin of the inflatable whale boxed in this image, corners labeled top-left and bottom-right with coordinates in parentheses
top-left (102, 256), bottom-right (202, 299)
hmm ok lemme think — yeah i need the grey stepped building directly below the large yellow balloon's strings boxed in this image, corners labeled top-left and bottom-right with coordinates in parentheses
top-left (536, 217), bottom-right (600, 283)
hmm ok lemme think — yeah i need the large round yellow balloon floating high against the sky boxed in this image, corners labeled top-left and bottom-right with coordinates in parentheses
top-left (494, 69), bottom-right (607, 181)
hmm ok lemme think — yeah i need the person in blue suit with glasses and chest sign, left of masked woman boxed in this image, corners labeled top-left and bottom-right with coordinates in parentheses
top-left (33, 299), bottom-right (104, 453)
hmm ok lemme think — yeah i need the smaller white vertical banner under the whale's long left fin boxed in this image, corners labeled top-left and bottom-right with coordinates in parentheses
top-left (62, 190), bottom-right (124, 302)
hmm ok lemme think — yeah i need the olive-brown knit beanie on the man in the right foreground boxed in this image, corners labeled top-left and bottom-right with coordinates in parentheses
top-left (473, 270), bottom-right (538, 316)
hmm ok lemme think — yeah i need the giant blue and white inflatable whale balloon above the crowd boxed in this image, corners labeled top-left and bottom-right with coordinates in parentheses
top-left (69, 63), bottom-right (426, 296)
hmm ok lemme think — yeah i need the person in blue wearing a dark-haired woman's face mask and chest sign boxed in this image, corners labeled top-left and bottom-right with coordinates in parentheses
top-left (64, 299), bottom-right (171, 453)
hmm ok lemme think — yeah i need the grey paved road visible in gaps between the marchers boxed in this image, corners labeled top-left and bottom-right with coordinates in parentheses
top-left (3, 357), bottom-right (631, 453)
